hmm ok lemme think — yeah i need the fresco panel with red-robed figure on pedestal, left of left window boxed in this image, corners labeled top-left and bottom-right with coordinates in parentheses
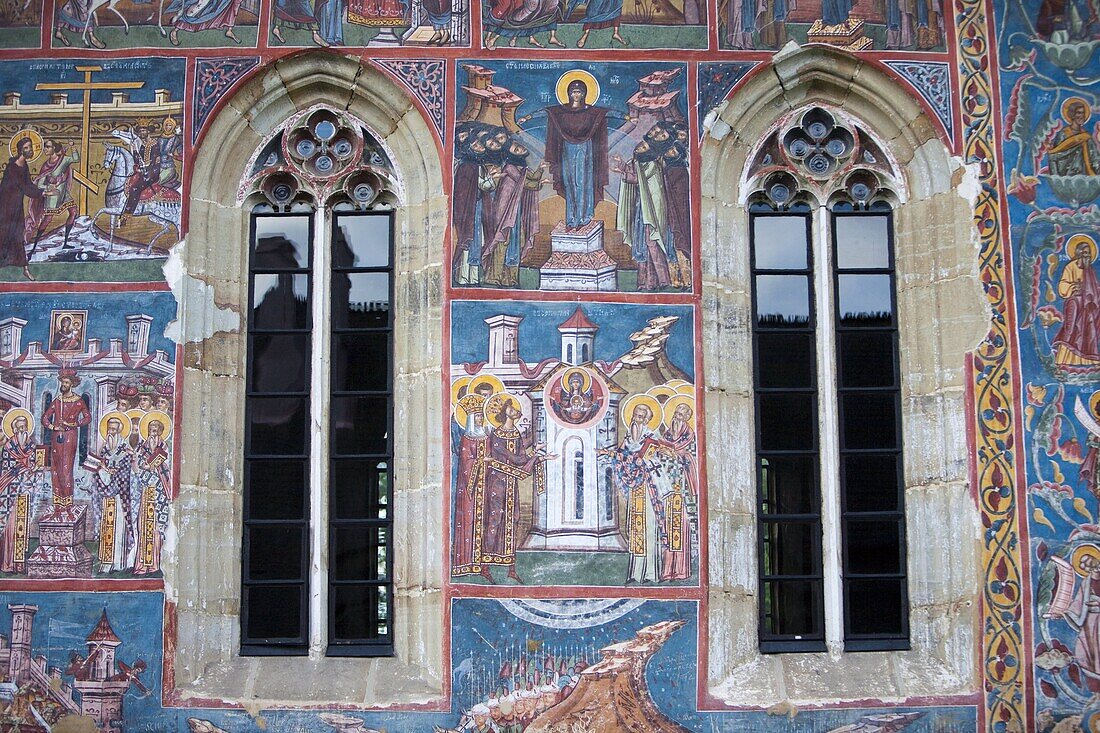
top-left (0, 292), bottom-right (177, 579)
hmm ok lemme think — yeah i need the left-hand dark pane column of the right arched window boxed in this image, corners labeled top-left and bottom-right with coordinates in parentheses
top-left (750, 208), bottom-right (825, 652)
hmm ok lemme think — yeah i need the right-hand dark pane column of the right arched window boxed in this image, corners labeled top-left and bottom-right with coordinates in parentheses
top-left (832, 208), bottom-right (909, 650)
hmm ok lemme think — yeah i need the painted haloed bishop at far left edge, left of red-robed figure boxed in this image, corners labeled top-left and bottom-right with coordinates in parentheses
top-left (0, 407), bottom-right (37, 573)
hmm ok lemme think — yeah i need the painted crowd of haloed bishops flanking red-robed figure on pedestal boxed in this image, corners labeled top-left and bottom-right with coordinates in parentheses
top-left (0, 368), bottom-right (173, 576)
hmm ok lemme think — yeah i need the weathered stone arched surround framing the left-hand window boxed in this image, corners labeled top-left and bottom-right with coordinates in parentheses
top-left (165, 52), bottom-right (448, 705)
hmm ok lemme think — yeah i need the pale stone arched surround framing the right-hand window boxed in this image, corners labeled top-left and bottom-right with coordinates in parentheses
top-left (701, 45), bottom-right (990, 707)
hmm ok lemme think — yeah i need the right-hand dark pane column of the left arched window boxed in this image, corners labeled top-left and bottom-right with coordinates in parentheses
top-left (327, 214), bottom-right (394, 656)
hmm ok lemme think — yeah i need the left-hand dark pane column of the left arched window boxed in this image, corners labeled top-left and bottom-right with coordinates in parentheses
top-left (241, 208), bottom-right (312, 654)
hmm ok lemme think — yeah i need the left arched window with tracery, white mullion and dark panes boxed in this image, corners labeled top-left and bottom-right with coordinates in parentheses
top-left (241, 106), bottom-right (399, 656)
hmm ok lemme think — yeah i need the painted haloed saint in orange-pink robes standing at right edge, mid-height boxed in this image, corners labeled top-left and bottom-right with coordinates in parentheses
top-left (1052, 234), bottom-right (1100, 370)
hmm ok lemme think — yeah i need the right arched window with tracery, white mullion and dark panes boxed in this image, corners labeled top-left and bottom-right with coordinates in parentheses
top-left (748, 107), bottom-right (909, 652)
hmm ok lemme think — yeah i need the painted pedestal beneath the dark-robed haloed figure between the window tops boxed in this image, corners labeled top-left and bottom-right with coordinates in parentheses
top-left (539, 220), bottom-right (618, 292)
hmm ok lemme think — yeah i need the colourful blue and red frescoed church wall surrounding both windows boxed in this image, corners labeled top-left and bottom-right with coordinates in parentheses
top-left (0, 0), bottom-right (1073, 717)
